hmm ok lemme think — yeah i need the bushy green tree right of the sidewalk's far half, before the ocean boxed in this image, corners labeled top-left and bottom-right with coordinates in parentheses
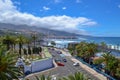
top-left (76, 42), bottom-right (97, 63)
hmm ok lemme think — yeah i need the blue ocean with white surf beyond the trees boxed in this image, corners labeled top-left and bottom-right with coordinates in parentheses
top-left (48, 37), bottom-right (120, 48)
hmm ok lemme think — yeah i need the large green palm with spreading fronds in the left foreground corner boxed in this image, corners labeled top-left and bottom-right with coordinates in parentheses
top-left (0, 45), bottom-right (22, 80)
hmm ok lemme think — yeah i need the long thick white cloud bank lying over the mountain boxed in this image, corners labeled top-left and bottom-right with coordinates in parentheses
top-left (0, 0), bottom-right (97, 34)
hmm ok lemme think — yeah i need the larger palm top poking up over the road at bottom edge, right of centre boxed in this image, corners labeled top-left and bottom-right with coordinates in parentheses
top-left (59, 72), bottom-right (87, 80)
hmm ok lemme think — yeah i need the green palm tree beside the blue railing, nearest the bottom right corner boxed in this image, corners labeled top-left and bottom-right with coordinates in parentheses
top-left (94, 53), bottom-right (119, 76)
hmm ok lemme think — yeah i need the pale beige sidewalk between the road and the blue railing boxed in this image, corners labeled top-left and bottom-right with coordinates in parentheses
top-left (61, 50), bottom-right (107, 80)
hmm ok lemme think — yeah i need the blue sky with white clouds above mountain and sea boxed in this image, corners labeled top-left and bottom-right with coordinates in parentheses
top-left (0, 0), bottom-right (120, 37)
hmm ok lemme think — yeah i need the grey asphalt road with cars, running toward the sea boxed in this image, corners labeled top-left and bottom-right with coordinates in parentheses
top-left (26, 49), bottom-right (99, 80)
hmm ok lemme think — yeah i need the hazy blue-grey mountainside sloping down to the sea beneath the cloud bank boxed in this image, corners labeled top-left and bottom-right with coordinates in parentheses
top-left (0, 23), bottom-right (91, 38)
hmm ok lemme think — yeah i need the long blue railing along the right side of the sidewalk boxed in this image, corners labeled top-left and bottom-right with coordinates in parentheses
top-left (75, 57), bottom-right (116, 80)
